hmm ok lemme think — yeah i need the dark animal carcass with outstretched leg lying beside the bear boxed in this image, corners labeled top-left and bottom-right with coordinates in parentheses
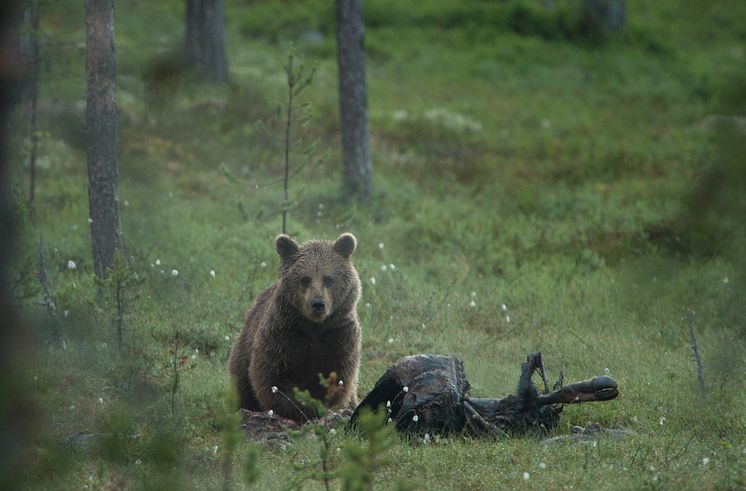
top-left (350, 353), bottom-right (619, 436)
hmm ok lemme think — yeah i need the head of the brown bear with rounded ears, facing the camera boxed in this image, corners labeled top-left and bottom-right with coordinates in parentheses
top-left (275, 233), bottom-right (360, 323)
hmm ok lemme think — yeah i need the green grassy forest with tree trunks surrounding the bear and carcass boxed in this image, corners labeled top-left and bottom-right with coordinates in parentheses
top-left (0, 0), bottom-right (746, 489)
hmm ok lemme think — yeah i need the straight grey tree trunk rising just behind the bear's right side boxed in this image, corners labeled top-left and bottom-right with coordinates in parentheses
top-left (336, 0), bottom-right (373, 199)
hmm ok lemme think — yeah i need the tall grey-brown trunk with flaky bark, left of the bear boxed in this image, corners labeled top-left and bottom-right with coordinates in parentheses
top-left (85, 0), bottom-right (123, 278)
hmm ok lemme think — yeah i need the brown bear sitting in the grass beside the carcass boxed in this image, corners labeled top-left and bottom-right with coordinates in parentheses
top-left (230, 233), bottom-right (360, 422)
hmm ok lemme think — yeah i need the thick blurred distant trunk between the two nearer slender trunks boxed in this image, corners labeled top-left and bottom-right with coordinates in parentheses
top-left (185, 0), bottom-right (228, 83)
